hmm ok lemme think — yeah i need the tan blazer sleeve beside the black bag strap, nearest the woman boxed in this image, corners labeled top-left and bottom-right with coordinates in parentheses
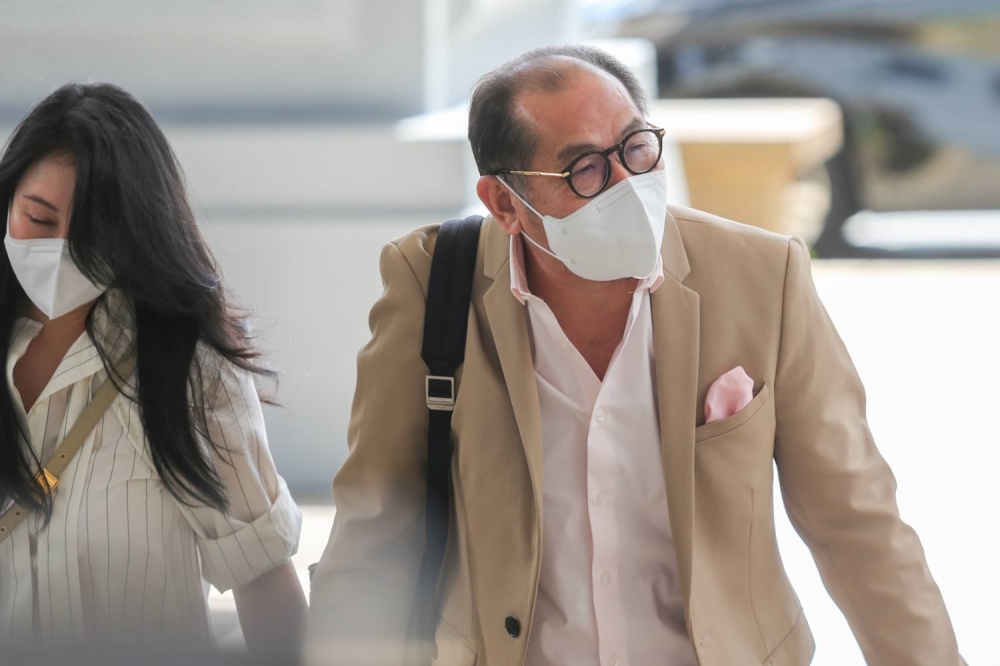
top-left (306, 239), bottom-right (430, 666)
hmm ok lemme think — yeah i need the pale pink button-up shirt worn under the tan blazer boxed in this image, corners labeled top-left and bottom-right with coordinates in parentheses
top-left (510, 237), bottom-right (697, 666)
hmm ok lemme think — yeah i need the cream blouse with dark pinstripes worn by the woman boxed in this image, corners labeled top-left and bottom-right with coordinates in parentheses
top-left (0, 299), bottom-right (301, 646)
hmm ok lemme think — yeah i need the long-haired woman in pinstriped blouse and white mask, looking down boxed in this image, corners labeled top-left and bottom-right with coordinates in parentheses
top-left (0, 84), bottom-right (305, 649)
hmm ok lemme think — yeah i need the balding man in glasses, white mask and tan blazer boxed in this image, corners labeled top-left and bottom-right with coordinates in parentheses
top-left (311, 47), bottom-right (961, 666)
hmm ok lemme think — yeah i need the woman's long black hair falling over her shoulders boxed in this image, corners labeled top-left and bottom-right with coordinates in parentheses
top-left (0, 83), bottom-right (273, 515)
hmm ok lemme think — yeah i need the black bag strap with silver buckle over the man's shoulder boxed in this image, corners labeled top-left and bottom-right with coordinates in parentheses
top-left (411, 215), bottom-right (483, 641)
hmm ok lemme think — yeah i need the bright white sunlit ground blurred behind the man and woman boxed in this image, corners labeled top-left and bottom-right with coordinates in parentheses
top-left (210, 262), bottom-right (1000, 666)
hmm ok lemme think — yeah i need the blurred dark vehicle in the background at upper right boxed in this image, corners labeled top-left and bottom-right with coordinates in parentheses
top-left (594, 0), bottom-right (1000, 256)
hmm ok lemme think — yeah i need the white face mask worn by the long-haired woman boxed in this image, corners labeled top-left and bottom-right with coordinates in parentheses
top-left (3, 202), bottom-right (107, 319)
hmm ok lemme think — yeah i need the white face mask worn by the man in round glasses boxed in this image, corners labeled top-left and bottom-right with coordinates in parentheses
top-left (500, 169), bottom-right (667, 282)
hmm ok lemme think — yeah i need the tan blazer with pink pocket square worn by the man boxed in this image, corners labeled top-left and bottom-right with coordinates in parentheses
top-left (311, 208), bottom-right (961, 666)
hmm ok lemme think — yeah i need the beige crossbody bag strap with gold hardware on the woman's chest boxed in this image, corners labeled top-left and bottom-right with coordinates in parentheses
top-left (0, 355), bottom-right (136, 543)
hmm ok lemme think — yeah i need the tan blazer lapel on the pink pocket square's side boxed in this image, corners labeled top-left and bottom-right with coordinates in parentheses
top-left (650, 213), bottom-right (700, 607)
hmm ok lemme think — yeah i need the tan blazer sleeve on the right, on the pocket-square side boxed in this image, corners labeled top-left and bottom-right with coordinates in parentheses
top-left (775, 233), bottom-right (963, 666)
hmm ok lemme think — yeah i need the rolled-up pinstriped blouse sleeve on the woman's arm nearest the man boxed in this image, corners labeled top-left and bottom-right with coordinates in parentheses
top-left (181, 356), bottom-right (302, 592)
